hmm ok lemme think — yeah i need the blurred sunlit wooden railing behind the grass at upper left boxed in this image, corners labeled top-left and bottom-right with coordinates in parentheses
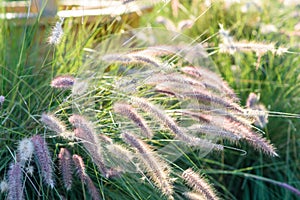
top-left (0, 0), bottom-right (159, 27)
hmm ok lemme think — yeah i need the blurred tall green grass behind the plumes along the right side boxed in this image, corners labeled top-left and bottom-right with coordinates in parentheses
top-left (148, 1), bottom-right (299, 199)
